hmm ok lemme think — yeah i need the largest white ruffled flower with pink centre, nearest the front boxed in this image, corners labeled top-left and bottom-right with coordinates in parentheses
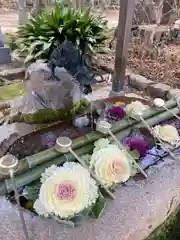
top-left (36, 163), bottom-right (98, 219)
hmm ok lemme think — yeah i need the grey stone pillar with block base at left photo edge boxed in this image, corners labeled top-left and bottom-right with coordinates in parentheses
top-left (0, 27), bottom-right (11, 64)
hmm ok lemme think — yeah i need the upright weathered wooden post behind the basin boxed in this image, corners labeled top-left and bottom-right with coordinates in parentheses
top-left (110, 0), bottom-right (135, 96)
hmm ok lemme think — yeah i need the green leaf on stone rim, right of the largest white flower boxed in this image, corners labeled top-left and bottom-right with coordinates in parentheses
top-left (89, 194), bottom-right (107, 218)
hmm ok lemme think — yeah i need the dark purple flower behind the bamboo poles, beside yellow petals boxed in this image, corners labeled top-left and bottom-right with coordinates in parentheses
top-left (107, 106), bottom-right (126, 122)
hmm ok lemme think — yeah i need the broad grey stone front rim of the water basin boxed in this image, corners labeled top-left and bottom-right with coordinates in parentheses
top-left (0, 97), bottom-right (180, 240)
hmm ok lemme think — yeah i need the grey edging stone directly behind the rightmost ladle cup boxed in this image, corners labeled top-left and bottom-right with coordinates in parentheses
top-left (147, 83), bottom-right (170, 98)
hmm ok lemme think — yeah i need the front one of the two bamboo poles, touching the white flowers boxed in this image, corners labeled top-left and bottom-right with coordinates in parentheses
top-left (0, 107), bottom-right (179, 196)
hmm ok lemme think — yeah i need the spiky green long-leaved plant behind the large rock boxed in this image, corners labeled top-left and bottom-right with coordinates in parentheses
top-left (16, 5), bottom-right (107, 62)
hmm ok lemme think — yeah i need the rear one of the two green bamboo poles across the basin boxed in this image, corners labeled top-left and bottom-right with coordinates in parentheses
top-left (0, 100), bottom-right (176, 180)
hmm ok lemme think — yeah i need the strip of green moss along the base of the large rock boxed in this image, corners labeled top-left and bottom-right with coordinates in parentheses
top-left (19, 99), bottom-right (89, 124)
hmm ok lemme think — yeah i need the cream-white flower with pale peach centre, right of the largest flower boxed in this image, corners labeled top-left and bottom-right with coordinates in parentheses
top-left (90, 144), bottom-right (131, 187)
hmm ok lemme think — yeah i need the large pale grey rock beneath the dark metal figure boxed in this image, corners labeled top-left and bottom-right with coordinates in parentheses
top-left (11, 62), bottom-right (81, 114)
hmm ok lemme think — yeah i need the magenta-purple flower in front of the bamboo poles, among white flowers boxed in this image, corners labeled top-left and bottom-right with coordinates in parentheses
top-left (127, 136), bottom-right (149, 157)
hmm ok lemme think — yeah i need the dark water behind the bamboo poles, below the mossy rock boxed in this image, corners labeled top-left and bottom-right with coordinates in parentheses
top-left (4, 115), bottom-right (95, 159)
